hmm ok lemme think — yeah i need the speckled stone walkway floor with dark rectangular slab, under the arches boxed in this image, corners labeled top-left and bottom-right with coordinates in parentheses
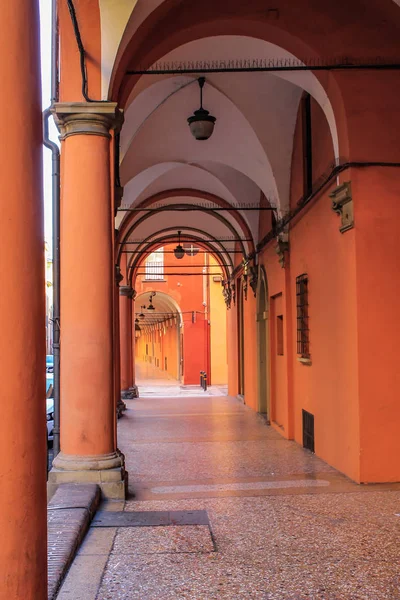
top-left (59, 396), bottom-right (400, 600)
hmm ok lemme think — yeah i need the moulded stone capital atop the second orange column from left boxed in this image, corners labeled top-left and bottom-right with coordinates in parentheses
top-left (51, 102), bottom-right (124, 140)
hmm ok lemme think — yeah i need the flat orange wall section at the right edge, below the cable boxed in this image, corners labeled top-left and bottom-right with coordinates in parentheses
top-left (351, 168), bottom-right (400, 481)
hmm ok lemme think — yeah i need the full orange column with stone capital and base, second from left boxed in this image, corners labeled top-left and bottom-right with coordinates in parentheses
top-left (49, 102), bottom-right (125, 498)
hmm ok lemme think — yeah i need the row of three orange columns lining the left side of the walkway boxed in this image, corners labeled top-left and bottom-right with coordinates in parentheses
top-left (0, 17), bottom-right (133, 600)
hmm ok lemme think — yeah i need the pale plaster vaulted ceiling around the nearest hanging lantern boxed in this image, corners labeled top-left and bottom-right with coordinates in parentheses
top-left (111, 24), bottom-right (339, 266)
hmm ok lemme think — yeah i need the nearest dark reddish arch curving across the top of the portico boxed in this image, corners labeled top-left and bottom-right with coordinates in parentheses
top-left (110, 0), bottom-right (350, 155)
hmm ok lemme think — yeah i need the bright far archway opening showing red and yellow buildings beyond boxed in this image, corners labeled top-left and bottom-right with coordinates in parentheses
top-left (131, 241), bottom-right (228, 388)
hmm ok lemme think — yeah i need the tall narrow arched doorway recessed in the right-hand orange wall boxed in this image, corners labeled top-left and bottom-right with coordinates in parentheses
top-left (257, 266), bottom-right (270, 421)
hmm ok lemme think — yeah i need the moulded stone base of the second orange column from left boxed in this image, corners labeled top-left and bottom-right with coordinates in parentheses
top-left (47, 452), bottom-right (128, 500)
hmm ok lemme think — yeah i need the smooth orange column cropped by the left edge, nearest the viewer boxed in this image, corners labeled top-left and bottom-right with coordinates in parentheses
top-left (0, 0), bottom-right (47, 600)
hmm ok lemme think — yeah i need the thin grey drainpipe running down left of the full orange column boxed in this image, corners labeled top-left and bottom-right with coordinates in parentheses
top-left (43, 0), bottom-right (60, 458)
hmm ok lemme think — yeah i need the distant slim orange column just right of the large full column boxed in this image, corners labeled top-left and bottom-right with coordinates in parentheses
top-left (119, 285), bottom-right (133, 399)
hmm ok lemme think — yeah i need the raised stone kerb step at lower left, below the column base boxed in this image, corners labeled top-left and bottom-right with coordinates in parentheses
top-left (47, 483), bottom-right (101, 600)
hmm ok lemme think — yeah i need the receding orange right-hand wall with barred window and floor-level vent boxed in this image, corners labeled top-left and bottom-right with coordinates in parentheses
top-left (228, 102), bottom-right (360, 480)
